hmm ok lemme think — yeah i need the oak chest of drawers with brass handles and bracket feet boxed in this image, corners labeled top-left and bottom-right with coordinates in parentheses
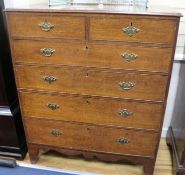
top-left (6, 2), bottom-right (180, 175)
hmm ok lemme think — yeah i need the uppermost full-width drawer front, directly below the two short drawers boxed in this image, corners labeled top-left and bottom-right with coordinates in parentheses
top-left (13, 40), bottom-right (172, 72)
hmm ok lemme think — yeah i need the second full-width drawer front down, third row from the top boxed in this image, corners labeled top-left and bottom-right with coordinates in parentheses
top-left (16, 66), bottom-right (168, 100)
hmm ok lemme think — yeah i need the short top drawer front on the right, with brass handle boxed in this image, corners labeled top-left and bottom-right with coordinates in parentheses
top-left (90, 16), bottom-right (176, 44)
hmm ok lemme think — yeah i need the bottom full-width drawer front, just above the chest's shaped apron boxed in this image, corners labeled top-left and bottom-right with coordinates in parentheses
top-left (25, 118), bottom-right (158, 157)
